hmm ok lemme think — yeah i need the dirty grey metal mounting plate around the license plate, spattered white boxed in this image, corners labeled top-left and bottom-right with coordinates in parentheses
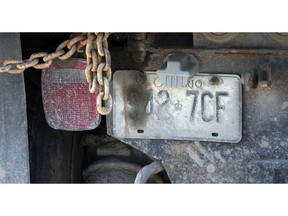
top-left (108, 46), bottom-right (288, 183)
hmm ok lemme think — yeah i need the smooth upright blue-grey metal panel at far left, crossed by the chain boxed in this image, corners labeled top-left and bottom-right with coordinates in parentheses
top-left (0, 33), bottom-right (30, 183)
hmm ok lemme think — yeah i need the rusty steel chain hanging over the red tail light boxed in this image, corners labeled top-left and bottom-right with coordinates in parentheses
top-left (0, 32), bottom-right (112, 115)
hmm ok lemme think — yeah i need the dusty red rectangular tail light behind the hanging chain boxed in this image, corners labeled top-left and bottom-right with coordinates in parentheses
top-left (42, 59), bottom-right (101, 131)
